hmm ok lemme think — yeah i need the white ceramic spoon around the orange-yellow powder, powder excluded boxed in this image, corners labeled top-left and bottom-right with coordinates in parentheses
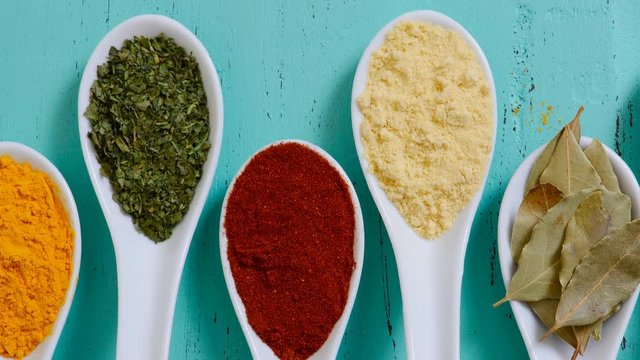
top-left (0, 142), bottom-right (82, 360)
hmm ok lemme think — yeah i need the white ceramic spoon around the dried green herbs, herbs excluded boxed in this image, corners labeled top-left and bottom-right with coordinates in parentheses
top-left (78, 15), bottom-right (223, 360)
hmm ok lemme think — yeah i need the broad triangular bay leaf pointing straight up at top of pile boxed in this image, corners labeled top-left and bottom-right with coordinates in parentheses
top-left (540, 126), bottom-right (602, 195)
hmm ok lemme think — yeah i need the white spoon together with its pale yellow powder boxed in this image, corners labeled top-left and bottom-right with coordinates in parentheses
top-left (351, 11), bottom-right (497, 359)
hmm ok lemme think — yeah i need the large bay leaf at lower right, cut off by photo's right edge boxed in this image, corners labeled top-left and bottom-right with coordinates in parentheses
top-left (543, 219), bottom-right (640, 338)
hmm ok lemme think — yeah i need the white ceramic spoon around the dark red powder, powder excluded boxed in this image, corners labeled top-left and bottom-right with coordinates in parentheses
top-left (220, 140), bottom-right (364, 360)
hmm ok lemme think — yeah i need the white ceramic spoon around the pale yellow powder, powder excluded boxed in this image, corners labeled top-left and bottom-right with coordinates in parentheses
top-left (351, 10), bottom-right (497, 359)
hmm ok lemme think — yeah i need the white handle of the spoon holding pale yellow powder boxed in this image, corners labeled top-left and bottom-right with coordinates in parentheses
top-left (392, 231), bottom-right (466, 360)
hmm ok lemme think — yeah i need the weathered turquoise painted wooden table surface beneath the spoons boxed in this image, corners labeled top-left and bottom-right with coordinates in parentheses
top-left (0, 0), bottom-right (640, 359)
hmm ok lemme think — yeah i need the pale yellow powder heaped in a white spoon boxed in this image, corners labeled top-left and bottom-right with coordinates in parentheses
top-left (358, 22), bottom-right (495, 238)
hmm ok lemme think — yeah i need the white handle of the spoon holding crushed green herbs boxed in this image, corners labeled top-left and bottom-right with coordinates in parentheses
top-left (114, 231), bottom-right (184, 360)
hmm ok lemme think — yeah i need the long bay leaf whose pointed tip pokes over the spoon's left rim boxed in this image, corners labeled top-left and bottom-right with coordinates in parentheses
top-left (493, 189), bottom-right (594, 307)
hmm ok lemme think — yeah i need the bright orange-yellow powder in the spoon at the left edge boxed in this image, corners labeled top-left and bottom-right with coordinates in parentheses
top-left (0, 156), bottom-right (74, 359)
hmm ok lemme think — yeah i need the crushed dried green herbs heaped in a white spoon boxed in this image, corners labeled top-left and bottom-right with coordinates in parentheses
top-left (85, 34), bottom-right (210, 242)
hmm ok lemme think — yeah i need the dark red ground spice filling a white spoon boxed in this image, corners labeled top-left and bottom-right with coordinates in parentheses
top-left (224, 142), bottom-right (355, 359)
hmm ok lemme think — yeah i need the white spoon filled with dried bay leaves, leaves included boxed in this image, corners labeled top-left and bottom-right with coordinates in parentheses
top-left (498, 110), bottom-right (640, 360)
